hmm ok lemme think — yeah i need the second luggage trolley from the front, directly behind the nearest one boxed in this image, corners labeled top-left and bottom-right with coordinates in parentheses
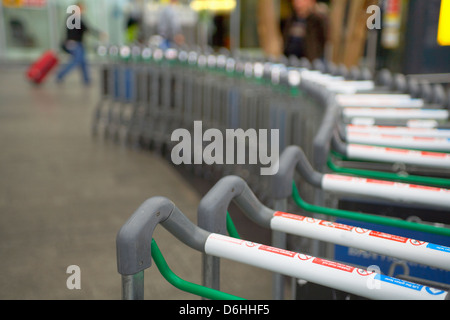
top-left (198, 176), bottom-right (450, 298)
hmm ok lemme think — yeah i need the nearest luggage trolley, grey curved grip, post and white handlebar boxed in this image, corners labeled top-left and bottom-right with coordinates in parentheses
top-left (116, 194), bottom-right (448, 299)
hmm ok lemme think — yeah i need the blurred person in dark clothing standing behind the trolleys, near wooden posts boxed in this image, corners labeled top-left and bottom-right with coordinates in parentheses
top-left (283, 0), bottom-right (328, 62)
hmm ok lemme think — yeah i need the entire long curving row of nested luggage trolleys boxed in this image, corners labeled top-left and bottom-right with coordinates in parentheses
top-left (89, 46), bottom-right (450, 299)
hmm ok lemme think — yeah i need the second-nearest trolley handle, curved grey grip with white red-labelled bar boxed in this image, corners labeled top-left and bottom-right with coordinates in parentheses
top-left (204, 176), bottom-right (450, 270)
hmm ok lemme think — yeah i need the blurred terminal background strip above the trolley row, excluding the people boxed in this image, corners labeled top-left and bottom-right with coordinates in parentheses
top-left (0, 0), bottom-right (450, 74)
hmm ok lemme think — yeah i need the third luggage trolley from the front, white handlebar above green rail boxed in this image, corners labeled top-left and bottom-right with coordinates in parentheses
top-left (273, 146), bottom-right (450, 296)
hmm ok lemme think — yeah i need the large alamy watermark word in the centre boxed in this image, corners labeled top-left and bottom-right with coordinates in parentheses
top-left (171, 121), bottom-right (279, 175)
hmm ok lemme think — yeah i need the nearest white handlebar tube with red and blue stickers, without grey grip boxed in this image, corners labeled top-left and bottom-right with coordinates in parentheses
top-left (205, 233), bottom-right (448, 300)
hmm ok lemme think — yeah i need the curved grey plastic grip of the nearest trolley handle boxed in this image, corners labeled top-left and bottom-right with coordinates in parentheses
top-left (116, 197), bottom-right (210, 275)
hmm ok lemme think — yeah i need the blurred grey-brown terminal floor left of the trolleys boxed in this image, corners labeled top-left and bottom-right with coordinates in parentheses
top-left (0, 65), bottom-right (271, 300)
